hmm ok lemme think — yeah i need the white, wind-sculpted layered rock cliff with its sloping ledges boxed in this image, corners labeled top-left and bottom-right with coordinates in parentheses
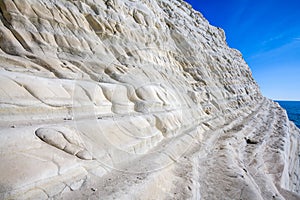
top-left (0, 0), bottom-right (300, 199)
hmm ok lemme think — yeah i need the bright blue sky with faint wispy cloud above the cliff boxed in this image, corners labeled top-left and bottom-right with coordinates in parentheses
top-left (186, 0), bottom-right (300, 100)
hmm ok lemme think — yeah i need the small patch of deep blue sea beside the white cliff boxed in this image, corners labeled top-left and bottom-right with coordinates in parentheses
top-left (276, 101), bottom-right (300, 128)
